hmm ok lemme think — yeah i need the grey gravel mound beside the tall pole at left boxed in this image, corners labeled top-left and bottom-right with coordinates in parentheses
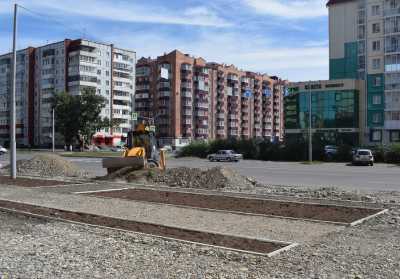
top-left (3, 154), bottom-right (86, 177)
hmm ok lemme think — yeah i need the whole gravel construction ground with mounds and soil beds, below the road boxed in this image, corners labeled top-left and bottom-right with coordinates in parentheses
top-left (0, 154), bottom-right (400, 278)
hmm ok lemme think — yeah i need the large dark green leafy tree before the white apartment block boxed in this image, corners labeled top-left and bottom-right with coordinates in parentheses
top-left (53, 90), bottom-right (112, 148)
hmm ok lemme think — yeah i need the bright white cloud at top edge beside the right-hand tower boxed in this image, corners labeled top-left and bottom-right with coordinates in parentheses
top-left (243, 0), bottom-right (328, 19)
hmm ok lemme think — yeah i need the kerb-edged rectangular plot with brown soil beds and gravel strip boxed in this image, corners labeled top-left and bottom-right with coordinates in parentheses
top-left (0, 178), bottom-right (385, 256)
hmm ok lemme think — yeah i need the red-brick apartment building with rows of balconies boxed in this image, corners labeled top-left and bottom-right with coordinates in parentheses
top-left (135, 50), bottom-right (285, 149)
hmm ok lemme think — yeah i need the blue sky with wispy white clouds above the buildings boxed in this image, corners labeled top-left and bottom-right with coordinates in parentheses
top-left (0, 0), bottom-right (329, 81)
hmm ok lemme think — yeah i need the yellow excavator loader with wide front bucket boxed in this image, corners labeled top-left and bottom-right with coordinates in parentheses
top-left (103, 123), bottom-right (166, 174)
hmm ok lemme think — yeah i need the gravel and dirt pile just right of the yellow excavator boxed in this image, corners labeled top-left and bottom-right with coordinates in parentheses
top-left (148, 167), bottom-right (254, 190)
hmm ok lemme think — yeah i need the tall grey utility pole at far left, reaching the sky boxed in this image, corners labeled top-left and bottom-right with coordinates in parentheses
top-left (10, 4), bottom-right (18, 179)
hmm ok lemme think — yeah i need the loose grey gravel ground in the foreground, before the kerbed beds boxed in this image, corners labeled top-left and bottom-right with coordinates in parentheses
top-left (0, 209), bottom-right (400, 278)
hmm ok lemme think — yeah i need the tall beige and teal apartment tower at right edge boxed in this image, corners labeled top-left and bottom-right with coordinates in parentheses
top-left (327, 0), bottom-right (400, 144)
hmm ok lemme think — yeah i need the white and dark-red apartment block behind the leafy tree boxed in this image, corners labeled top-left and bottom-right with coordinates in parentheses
top-left (0, 39), bottom-right (136, 149)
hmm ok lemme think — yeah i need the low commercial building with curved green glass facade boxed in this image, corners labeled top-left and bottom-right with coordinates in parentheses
top-left (285, 79), bottom-right (365, 145)
